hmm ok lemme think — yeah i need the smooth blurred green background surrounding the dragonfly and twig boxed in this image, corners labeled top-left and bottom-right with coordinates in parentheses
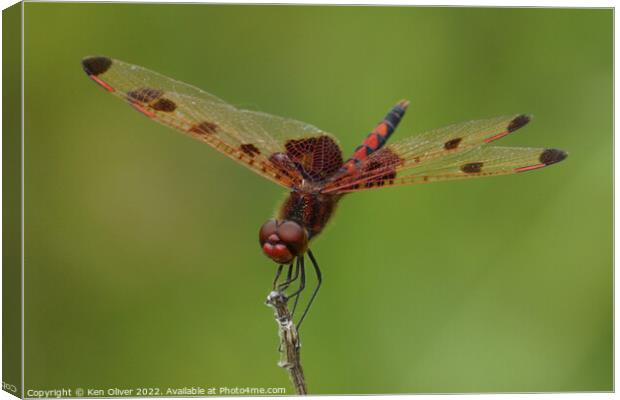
top-left (25, 3), bottom-right (613, 393)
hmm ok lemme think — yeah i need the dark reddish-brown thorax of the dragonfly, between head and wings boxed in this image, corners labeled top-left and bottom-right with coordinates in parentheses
top-left (279, 191), bottom-right (341, 239)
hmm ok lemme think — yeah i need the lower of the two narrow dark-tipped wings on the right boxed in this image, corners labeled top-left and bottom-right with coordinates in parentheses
top-left (324, 146), bottom-right (567, 193)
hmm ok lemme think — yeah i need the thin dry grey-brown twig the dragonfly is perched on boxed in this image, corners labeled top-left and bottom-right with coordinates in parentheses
top-left (266, 290), bottom-right (308, 395)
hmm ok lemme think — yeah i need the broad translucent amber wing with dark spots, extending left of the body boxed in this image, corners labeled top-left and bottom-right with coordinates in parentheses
top-left (82, 57), bottom-right (342, 187)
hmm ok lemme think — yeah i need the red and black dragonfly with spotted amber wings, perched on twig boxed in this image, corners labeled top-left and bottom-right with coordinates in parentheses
top-left (82, 56), bottom-right (567, 328)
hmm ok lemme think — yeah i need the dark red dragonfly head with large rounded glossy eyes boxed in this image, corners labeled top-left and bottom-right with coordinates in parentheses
top-left (258, 219), bottom-right (308, 264)
